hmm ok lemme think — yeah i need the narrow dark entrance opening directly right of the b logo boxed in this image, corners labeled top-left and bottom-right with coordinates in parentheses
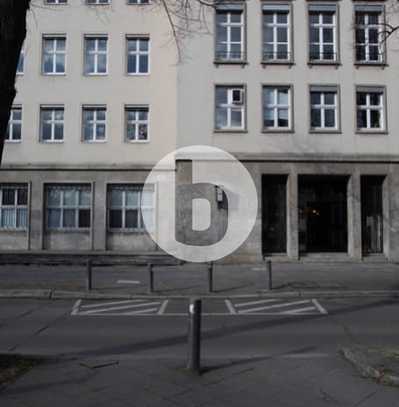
top-left (262, 175), bottom-right (287, 254)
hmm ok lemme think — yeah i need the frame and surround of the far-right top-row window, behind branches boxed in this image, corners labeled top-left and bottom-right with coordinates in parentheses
top-left (353, 3), bottom-right (387, 66)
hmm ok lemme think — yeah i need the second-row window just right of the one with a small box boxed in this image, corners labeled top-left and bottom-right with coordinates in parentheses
top-left (263, 86), bottom-right (291, 130)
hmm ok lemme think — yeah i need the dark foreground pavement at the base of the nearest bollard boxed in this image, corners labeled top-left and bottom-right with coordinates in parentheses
top-left (0, 354), bottom-right (399, 407)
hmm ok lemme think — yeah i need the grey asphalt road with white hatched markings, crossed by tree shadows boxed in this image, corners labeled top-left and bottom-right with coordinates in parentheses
top-left (0, 298), bottom-right (399, 359)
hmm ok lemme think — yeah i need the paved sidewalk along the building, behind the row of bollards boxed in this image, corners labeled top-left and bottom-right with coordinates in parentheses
top-left (0, 263), bottom-right (399, 298)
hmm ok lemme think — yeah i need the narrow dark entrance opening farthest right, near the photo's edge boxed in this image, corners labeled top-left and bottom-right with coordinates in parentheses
top-left (361, 176), bottom-right (384, 254)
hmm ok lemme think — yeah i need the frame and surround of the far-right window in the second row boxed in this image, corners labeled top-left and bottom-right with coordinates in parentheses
top-left (354, 85), bottom-right (388, 134)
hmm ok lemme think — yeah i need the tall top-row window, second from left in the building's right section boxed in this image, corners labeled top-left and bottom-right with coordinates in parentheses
top-left (263, 4), bottom-right (291, 62)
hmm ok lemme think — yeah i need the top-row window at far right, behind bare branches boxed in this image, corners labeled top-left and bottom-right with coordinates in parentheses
top-left (355, 6), bottom-right (384, 63)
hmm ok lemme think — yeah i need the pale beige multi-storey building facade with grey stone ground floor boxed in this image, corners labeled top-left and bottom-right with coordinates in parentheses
top-left (0, 0), bottom-right (399, 261)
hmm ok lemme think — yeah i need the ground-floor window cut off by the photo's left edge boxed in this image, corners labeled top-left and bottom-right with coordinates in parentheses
top-left (0, 184), bottom-right (28, 230)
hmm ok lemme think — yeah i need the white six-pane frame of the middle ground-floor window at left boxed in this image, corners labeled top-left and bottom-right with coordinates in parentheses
top-left (45, 184), bottom-right (93, 231)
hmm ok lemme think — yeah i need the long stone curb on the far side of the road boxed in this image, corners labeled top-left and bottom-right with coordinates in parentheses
top-left (0, 289), bottom-right (399, 300)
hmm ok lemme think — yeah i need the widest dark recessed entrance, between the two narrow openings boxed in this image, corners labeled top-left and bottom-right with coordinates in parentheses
top-left (298, 175), bottom-right (348, 253)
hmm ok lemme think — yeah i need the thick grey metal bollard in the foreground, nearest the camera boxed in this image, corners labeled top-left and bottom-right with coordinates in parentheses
top-left (187, 298), bottom-right (201, 374)
